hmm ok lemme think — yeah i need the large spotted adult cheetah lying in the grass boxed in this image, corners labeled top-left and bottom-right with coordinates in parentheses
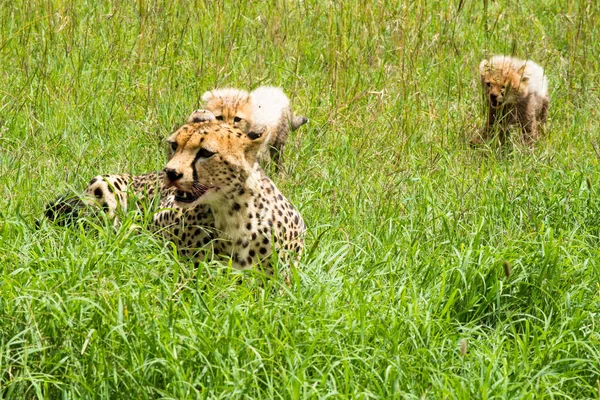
top-left (47, 111), bottom-right (306, 271)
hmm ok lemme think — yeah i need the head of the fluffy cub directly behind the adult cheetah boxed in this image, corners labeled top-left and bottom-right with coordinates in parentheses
top-left (202, 88), bottom-right (252, 133)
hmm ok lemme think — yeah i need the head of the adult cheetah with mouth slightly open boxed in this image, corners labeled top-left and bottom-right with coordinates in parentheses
top-left (164, 112), bottom-right (267, 207)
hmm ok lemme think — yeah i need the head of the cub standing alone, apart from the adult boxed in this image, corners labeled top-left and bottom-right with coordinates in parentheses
top-left (479, 57), bottom-right (529, 108)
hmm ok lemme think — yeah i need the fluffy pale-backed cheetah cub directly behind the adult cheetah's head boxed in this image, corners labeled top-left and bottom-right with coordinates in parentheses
top-left (202, 86), bottom-right (308, 169)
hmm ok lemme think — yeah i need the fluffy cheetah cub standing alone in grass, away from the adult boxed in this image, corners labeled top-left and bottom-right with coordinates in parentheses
top-left (471, 55), bottom-right (549, 145)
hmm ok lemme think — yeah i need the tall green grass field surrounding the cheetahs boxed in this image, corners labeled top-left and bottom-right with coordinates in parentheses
top-left (0, 0), bottom-right (600, 399)
